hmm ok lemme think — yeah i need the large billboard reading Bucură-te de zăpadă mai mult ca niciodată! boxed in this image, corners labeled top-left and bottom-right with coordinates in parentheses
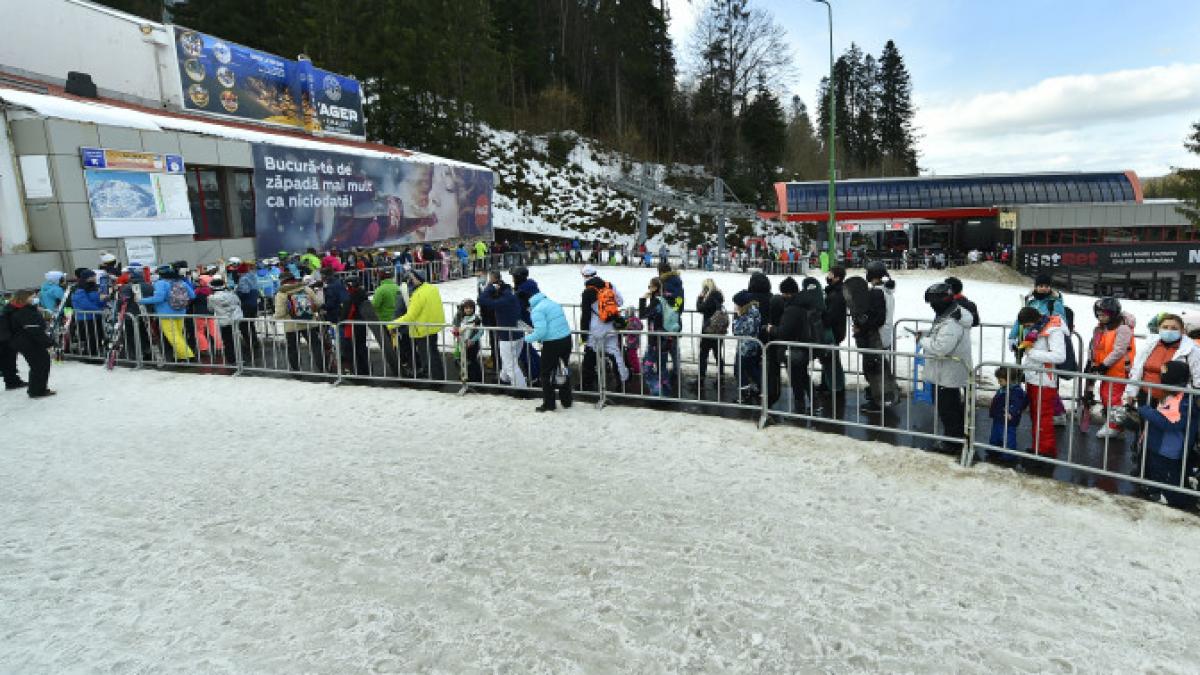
top-left (253, 144), bottom-right (493, 256)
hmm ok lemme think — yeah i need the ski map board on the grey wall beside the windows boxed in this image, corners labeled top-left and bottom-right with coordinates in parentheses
top-left (79, 148), bottom-right (196, 239)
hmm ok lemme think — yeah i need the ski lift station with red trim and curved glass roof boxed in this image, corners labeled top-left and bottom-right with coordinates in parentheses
top-left (775, 171), bottom-right (1200, 301)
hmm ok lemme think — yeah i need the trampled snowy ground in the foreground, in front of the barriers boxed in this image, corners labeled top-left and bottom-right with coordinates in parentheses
top-left (0, 362), bottom-right (1200, 673)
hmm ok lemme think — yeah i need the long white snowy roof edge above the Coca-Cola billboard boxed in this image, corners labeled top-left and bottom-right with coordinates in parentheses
top-left (0, 88), bottom-right (491, 171)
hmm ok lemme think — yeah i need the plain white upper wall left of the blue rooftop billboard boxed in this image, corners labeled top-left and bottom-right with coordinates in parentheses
top-left (0, 0), bottom-right (180, 107)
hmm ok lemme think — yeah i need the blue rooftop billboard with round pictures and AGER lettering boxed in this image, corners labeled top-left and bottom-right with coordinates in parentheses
top-left (175, 26), bottom-right (366, 138)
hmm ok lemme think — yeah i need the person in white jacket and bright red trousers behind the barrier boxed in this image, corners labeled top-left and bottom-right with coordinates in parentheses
top-left (1016, 307), bottom-right (1068, 458)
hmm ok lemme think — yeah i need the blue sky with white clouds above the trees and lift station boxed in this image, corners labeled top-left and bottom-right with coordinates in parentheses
top-left (668, 0), bottom-right (1200, 175)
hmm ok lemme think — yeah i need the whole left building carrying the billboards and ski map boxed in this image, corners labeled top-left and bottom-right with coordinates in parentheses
top-left (0, 0), bottom-right (493, 288)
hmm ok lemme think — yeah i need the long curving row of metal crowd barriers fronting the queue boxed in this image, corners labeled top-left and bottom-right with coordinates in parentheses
top-left (51, 294), bottom-right (1200, 509)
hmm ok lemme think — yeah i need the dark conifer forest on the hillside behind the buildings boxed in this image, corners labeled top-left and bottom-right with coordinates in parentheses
top-left (102, 0), bottom-right (918, 208)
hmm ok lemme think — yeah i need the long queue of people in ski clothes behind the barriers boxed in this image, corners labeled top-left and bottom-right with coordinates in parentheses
top-left (7, 251), bottom-right (1200, 500)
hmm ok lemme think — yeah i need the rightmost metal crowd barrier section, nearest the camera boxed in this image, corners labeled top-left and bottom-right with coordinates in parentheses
top-left (961, 362), bottom-right (1200, 497)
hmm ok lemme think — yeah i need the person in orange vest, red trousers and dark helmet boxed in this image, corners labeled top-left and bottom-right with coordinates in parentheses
top-left (1084, 298), bottom-right (1136, 438)
